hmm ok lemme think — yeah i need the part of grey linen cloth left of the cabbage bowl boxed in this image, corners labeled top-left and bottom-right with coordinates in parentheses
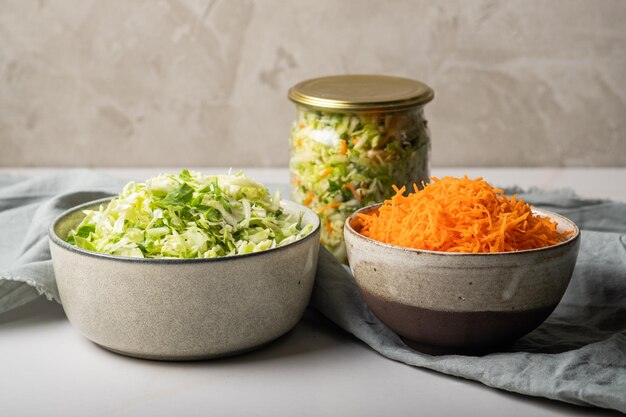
top-left (0, 170), bottom-right (124, 313)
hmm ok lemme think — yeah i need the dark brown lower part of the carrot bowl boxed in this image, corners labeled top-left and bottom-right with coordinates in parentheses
top-left (361, 289), bottom-right (556, 354)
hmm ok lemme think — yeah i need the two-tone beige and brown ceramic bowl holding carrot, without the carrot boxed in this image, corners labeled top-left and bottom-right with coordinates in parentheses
top-left (344, 205), bottom-right (580, 353)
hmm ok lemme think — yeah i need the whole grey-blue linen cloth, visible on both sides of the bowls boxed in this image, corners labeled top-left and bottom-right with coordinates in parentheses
top-left (0, 170), bottom-right (626, 412)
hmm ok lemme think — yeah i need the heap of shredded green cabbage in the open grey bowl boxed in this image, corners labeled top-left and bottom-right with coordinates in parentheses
top-left (66, 170), bottom-right (313, 258)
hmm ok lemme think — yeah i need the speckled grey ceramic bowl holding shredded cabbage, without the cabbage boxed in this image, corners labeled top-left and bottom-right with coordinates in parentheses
top-left (49, 199), bottom-right (320, 360)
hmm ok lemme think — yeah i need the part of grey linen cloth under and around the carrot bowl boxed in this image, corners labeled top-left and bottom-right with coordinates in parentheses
top-left (311, 189), bottom-right (626, 412)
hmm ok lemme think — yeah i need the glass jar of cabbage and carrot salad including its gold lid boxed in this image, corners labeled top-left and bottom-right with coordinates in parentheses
top-left (289, 75), bottom-right (434, 262)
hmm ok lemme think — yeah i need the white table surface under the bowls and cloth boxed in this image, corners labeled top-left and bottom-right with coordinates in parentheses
top-left (0, 168), bottom-right (626, 417)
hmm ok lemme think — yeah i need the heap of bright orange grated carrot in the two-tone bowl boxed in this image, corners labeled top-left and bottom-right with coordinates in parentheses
top-left (358, 176), bottom-right (573, 253)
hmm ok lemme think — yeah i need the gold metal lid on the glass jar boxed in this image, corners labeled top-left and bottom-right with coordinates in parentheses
top-left (288, 75), bottom-right (435, 111)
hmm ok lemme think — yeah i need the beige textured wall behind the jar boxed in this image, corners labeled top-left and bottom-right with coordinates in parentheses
top-left (0, 0), bottom-right (626, 166)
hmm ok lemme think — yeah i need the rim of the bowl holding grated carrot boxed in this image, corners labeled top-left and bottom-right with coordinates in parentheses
top-left (344, 203), bottom-right (580, 257)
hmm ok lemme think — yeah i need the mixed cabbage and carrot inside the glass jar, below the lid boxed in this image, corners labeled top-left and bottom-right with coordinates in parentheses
top-left (290, 107), bottom-right (430, 262)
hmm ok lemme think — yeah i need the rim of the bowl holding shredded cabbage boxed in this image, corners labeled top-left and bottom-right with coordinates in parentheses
top-left (48, 195), bottom-right (321, 265)
